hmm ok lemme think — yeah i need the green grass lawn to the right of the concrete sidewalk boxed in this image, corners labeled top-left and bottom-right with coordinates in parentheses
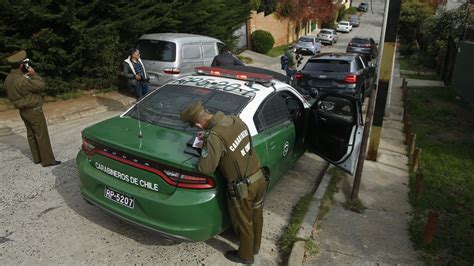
top-left (409, 88), bottom-right (474, 265)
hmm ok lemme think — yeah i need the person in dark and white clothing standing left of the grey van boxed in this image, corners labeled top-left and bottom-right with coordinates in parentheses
top-left (122, 48), bottom-right (149, 100)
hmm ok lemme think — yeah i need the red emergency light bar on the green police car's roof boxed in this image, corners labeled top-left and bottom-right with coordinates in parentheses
top-left (195, 66), bottom-right (273, 83)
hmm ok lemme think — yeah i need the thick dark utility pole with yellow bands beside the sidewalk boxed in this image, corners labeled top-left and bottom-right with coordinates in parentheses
top-left (367, 0), bottom-right (401, 161)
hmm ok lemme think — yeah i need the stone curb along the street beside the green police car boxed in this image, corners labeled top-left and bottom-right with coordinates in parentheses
top-left (288, 169), bottom-right (331, 266)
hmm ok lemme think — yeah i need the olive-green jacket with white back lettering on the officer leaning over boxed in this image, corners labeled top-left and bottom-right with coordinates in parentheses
top-left (198, 112), bottom-right (260, 181)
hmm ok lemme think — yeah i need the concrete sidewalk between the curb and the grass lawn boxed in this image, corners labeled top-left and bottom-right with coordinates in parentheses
top-left (290, 56), bottom-right (430, 265)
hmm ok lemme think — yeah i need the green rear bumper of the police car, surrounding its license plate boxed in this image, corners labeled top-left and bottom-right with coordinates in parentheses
top-left (76, 151), bottom-right (230, 241)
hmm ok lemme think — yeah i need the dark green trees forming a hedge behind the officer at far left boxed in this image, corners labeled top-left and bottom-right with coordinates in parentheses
top-left (0, 0), bottom-right (250, 95)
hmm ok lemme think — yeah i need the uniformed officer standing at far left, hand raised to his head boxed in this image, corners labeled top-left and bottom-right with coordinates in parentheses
top-left (5, 50), bottom-right (61, 167)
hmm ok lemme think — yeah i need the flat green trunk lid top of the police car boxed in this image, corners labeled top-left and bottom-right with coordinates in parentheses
top-left (83, 116), bottom-right (199, 170)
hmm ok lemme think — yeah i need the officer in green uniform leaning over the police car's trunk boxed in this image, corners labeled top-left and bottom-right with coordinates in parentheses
top-left (181, 101), bottom-right (266, 264)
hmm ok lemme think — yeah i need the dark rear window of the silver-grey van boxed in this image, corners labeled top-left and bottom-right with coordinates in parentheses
top-left (137, 40), bottom-right (176, 62)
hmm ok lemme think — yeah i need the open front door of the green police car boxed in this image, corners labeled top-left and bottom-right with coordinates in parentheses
top-left (306, 94), bottom-right (364, 174)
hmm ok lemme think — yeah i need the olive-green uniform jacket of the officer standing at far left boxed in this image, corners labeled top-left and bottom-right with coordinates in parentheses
top-left (5, 69), bottom-right (45, 109)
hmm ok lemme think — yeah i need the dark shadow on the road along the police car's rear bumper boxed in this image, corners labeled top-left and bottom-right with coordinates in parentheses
top-left (53, 159), bottom-right (177, 246)
